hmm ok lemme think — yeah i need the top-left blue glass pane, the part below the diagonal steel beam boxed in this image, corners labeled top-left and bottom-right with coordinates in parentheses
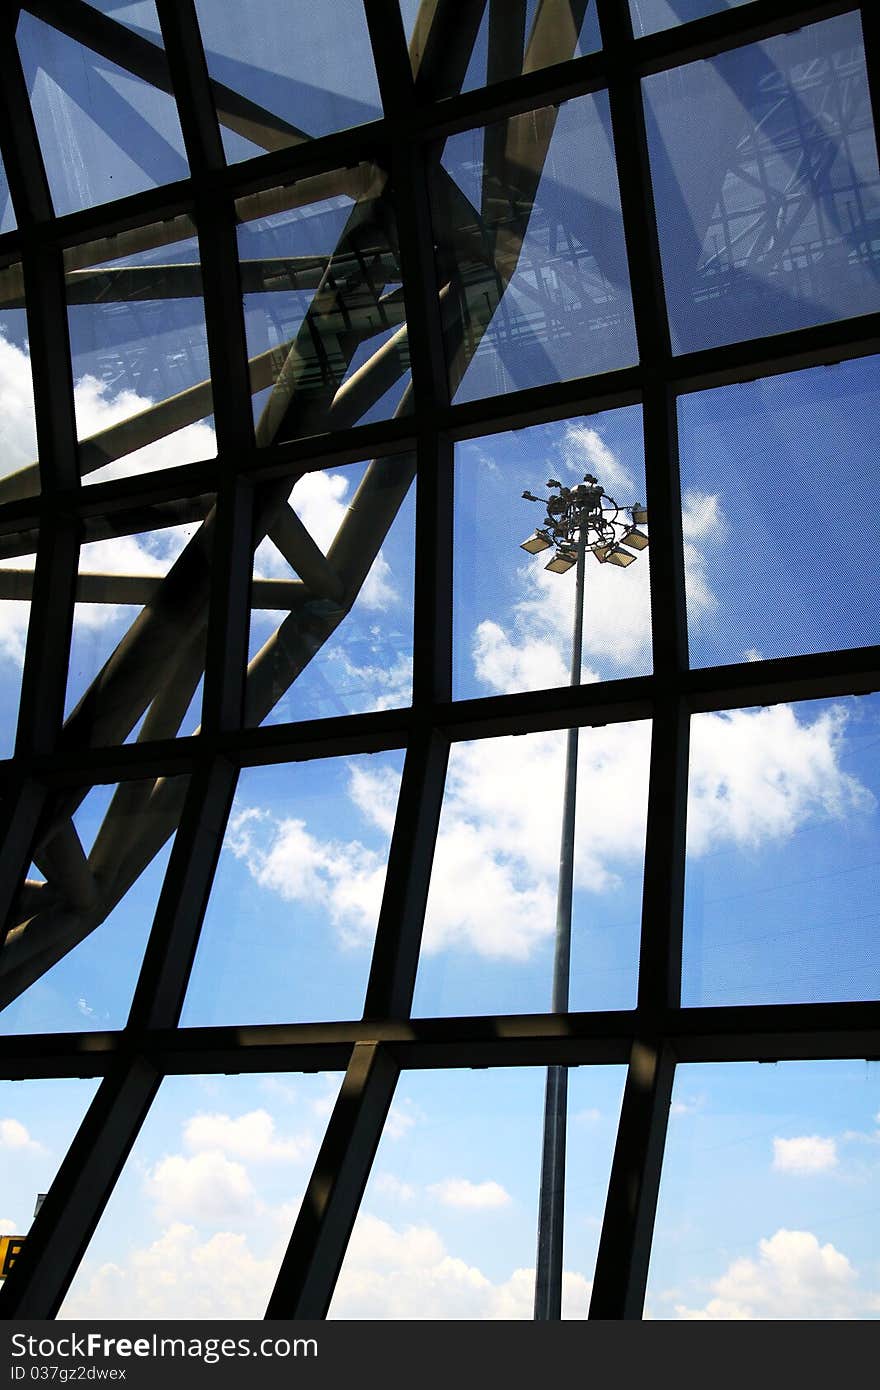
top-left (17, 13), bottom-right (189, 213)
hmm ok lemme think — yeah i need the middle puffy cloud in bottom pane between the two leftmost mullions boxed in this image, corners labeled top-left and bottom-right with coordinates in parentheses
top-left (145, 1150), bottom-right (256, 1226)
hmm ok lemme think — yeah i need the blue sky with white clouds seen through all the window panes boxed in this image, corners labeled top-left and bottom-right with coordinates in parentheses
top-left (0, 4), bottom-right (880, 1318)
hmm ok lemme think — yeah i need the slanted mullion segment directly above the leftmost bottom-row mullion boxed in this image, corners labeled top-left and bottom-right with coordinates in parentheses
top-left (127, 759), bottom-right (238, 1033)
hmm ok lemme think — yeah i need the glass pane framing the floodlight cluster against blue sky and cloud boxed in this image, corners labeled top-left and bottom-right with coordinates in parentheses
top-left (453, 406), bottom-right (651, 699)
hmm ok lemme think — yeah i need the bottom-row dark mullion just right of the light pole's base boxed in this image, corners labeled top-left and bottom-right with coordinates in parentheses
top-left (589, 1037), bottom-right (676, 1319)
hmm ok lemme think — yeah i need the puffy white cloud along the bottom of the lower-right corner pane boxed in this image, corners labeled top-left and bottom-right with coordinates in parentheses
top-left (676, 1229), bottom-right (874, 1321)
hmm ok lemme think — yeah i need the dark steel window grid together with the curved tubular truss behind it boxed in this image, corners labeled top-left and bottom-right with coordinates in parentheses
top-left (0, 0), bottom-right (880, 1318)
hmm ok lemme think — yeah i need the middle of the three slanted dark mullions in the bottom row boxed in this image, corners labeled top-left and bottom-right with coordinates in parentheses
top-left (266, 1041), bottom-right (400, 1318)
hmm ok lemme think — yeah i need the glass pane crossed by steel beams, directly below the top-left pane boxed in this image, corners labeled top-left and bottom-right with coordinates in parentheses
top-left (64, 217), bottom-right (217, 482)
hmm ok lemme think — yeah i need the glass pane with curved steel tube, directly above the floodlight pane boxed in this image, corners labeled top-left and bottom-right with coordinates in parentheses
top-left (432, 92), bottom-right (637, 400)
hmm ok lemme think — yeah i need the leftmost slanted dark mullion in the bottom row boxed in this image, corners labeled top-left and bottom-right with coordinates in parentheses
top-left (0, 1058), bottom-right (160, 1319)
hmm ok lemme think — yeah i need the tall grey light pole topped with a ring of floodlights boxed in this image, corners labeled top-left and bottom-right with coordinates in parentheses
top-left (523, 473), bottom-right (648, 1321)
